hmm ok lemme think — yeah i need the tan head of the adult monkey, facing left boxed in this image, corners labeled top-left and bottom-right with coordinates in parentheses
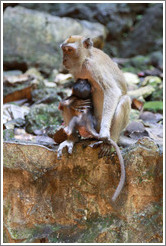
top-left (60, 36), bottom-right (93, 70)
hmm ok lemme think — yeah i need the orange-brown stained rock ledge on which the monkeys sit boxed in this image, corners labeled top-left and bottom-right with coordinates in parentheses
top-left (3, 138), bottom-right (162, 243)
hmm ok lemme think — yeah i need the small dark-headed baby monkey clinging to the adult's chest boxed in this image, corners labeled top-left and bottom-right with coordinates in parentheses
top-left (59, 79), bottom-right (98, 138)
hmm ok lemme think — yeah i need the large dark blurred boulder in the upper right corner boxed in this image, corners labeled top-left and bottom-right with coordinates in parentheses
top-left (121, 3), bottom-right (163, 57)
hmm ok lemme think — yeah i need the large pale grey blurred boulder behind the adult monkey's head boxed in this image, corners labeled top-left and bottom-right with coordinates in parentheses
top-left (4, 6), bottom-right (106, 74)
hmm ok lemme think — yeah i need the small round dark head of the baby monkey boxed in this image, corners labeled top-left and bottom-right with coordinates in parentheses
top-left (72, 79), bottom-right (91, 99)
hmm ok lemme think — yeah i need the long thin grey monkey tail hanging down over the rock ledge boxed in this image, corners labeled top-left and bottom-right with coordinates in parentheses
top-left (109, 139), bottom-right (125, 202)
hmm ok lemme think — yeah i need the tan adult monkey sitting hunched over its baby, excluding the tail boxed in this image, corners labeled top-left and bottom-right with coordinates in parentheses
top-left (61, 36), bottom-right (131, 145)
